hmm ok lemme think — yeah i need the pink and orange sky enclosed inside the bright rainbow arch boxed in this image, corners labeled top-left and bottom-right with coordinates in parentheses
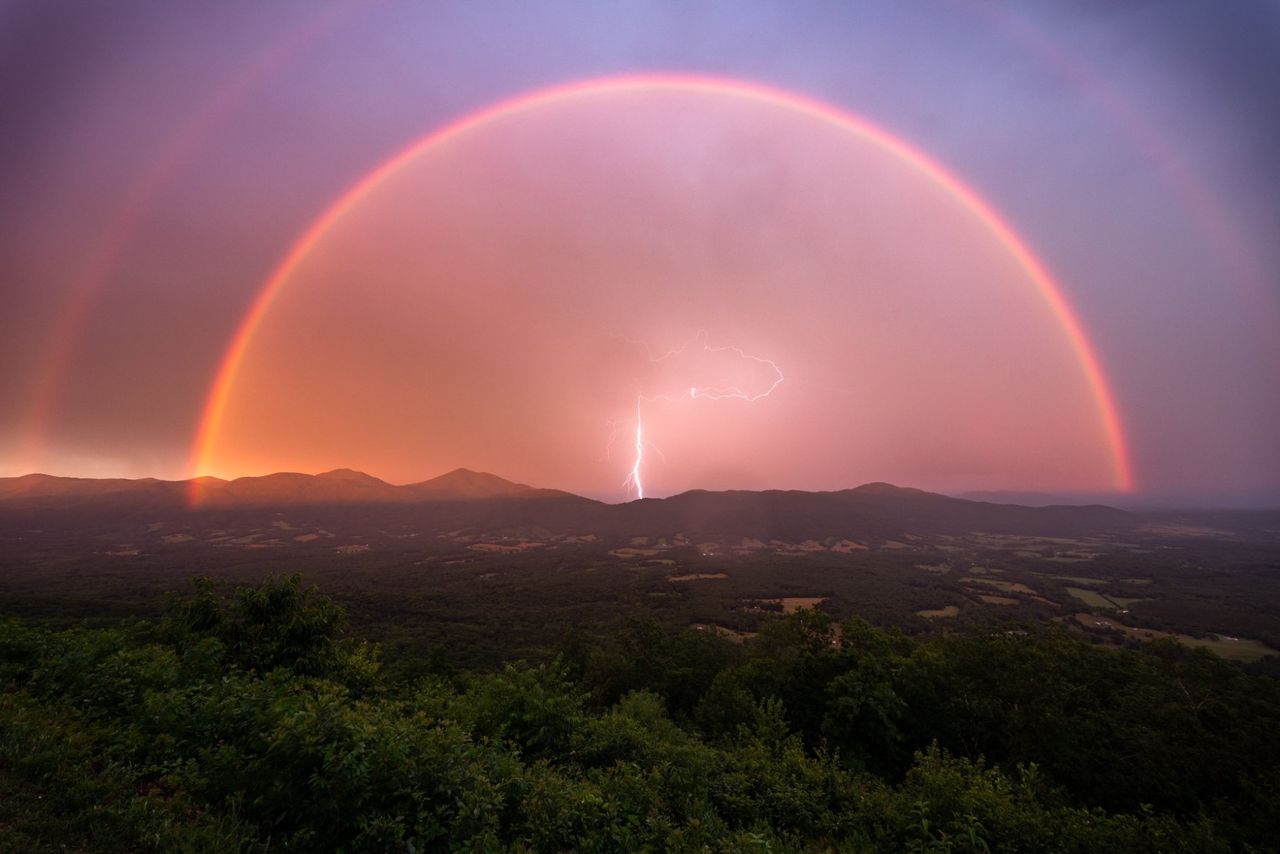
top-left (202, 90), bottom-right (1115, 497)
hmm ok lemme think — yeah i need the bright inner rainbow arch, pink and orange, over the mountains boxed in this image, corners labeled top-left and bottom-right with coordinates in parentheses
top-left (189, 74), bottom-right (1134, 498)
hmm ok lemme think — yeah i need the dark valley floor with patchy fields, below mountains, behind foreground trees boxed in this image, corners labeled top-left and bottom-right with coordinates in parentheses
top-left (0, 491), bottom-right (1280, 666)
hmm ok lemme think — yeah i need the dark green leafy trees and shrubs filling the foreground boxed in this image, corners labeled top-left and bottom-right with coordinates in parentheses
top-left (0, 576), bottom-right (1280, 853)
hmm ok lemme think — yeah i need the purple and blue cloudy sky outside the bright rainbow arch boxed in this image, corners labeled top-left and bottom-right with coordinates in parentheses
top-left (0, 0), bottom-right (1280, 502)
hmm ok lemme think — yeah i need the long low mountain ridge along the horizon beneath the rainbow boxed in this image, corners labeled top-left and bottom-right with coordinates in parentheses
top-left (0, 469), bottom-right (1134, 542)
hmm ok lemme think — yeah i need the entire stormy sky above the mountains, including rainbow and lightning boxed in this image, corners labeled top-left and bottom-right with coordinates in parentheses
top-left (0, 0), bottom-right (1280, 504)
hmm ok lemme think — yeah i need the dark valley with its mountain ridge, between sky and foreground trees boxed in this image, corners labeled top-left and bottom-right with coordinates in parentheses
top-left (0, 471), bottom-right (1280, 666)
